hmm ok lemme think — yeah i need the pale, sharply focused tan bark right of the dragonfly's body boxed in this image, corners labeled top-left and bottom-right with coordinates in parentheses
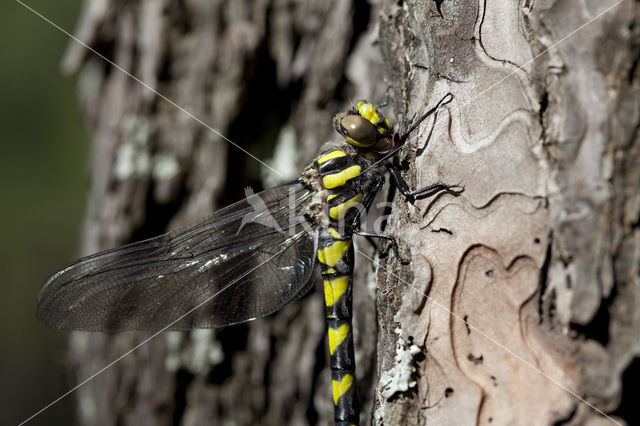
top-left (375, 1), bottom-right (640, 425)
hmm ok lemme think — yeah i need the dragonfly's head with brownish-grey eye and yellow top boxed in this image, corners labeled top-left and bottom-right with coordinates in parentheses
top-left (333, 101), bottom-right (393, 152)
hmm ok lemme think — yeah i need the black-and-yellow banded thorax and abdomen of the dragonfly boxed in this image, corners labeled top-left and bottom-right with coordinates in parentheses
top-left (308, 147), bottom-right (378, 425)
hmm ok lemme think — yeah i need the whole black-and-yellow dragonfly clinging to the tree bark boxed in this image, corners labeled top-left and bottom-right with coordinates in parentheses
top-left (36, 93), bottom-right (462, 425)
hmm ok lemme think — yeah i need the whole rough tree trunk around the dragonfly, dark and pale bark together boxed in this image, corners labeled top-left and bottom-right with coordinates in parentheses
top-left (64, 0), bottom-right (640, 425)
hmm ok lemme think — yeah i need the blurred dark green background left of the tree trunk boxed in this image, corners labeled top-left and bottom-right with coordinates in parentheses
top-left (0, 0), bottom-right (89, 425)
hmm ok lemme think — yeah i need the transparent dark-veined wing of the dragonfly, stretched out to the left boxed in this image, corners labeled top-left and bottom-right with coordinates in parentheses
top-left (37, 183), bottom-right (317, 331)
